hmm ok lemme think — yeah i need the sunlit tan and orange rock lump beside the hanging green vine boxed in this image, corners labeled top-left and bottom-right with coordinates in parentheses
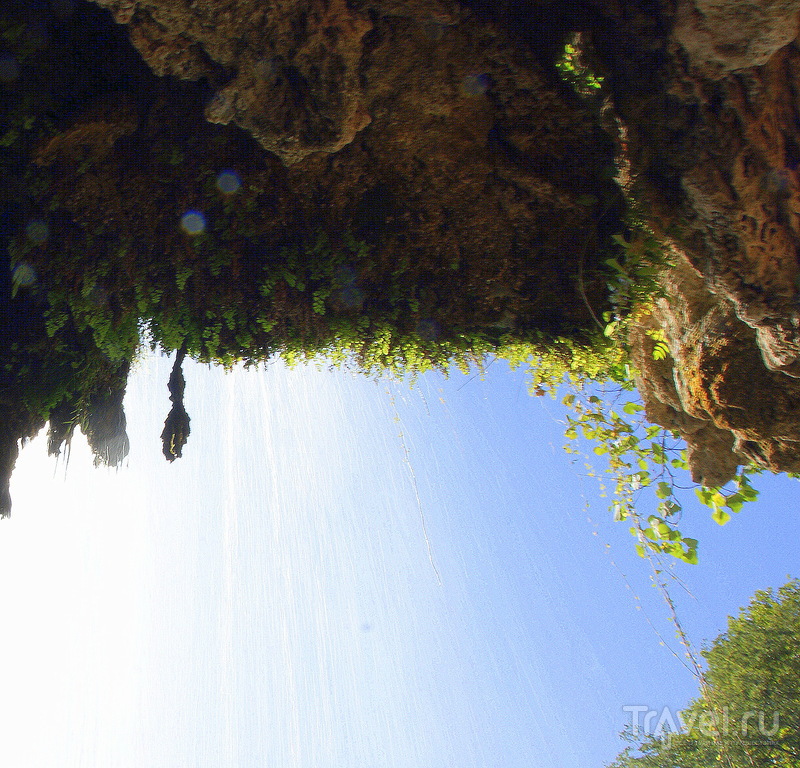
top-left (631, 254), bottom-right (800, 487)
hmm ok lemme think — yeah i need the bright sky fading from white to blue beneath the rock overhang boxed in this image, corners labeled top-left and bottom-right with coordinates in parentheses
top-left (0, 358), bottom-right (800, 768)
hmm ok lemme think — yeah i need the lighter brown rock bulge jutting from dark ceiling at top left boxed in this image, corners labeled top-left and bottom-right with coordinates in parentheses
top-left (91, 0), bottom-right (372, 163)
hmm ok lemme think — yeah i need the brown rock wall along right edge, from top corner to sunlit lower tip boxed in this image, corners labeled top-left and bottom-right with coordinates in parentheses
top-left (596, 2), bottom-right (800, 485)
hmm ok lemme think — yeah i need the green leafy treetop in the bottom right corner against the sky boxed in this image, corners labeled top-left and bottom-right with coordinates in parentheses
top-left (610, 579), bottom-right (800, 768)
